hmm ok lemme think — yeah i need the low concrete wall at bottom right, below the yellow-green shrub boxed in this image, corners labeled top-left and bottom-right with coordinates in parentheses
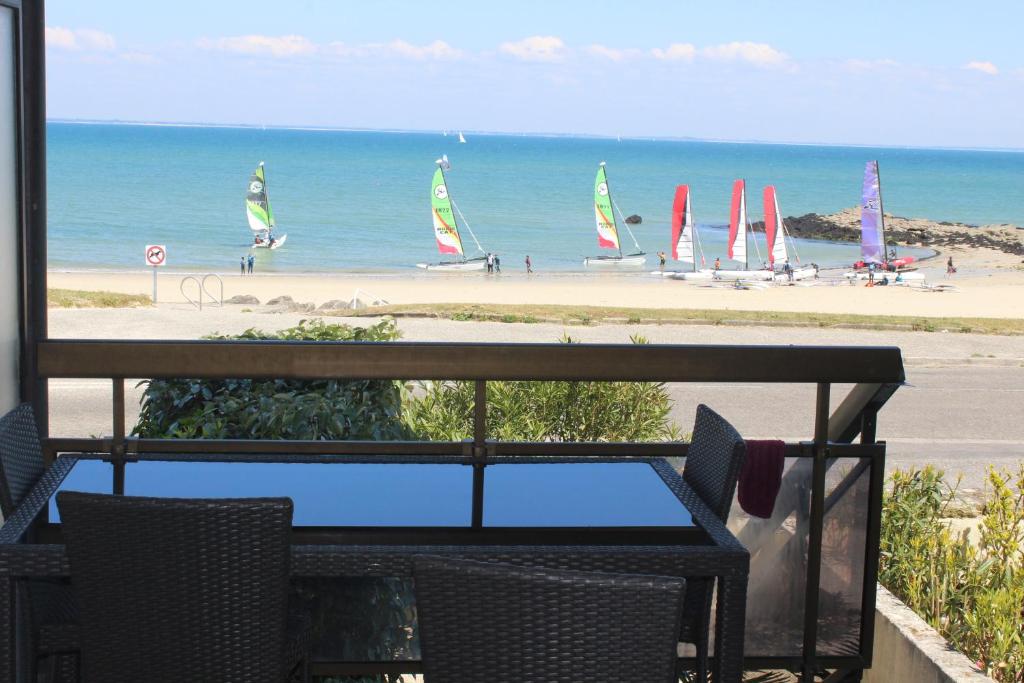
top-left (863, 586), bottom-right (992, 683)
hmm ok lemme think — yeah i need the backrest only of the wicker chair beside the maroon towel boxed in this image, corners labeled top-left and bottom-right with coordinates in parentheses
top-left (683, 403), bottom-right (746, 521)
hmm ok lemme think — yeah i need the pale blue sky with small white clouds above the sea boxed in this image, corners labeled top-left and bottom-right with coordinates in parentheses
top-left (46, 0), bottom-right (1024, 148)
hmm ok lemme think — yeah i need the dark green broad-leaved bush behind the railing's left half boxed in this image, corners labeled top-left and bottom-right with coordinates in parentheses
top-left (133, 319), bottom-right (406, 440)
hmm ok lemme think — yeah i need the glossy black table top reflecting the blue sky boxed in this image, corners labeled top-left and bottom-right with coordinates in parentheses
top-left (49, 460), bottom-right (694, 528)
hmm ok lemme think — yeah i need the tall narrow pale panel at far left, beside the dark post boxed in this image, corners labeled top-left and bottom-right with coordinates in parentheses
top-left (0, 7), bottom-right (20, 415)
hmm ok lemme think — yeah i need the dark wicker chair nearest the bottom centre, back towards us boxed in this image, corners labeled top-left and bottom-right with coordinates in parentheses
top-left (414, 556), bottom-right (686, 683)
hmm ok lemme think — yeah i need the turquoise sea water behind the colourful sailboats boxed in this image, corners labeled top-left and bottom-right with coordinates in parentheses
top-left (47, 123), bottom-right (1024, 272)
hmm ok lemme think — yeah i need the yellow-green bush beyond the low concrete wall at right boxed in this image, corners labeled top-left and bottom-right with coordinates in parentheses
top-left (879, 465), bottom-right (1024, 683)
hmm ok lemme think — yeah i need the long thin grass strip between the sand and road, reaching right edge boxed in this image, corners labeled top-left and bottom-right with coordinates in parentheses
top-left (345, 303), bottom-right (1024, 335)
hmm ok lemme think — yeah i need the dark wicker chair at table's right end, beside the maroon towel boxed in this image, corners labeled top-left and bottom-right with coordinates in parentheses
top-left (679, 403), bottom-right (746, 681)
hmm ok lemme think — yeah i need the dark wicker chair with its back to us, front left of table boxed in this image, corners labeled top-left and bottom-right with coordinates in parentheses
top-left (57, 492), bottom-right (308, 683)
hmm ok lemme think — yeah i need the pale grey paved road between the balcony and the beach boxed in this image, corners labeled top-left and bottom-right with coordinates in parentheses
top-left (50, 310), bottom-right (1024, 495)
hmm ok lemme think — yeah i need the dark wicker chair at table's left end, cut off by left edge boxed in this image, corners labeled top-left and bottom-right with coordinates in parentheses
top-left (0, 403), bottom-right (79, 682)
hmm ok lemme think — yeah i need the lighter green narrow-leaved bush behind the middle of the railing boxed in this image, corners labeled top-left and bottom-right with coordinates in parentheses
top-left (404, 337), bottom-right (680, 441)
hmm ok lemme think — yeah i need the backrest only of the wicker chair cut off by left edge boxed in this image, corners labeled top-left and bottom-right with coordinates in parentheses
top-left (0, 403), bottom-right (46, 519)
